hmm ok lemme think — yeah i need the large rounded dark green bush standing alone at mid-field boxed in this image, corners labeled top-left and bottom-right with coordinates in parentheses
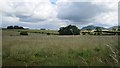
top-left (58, 25), bottom-right (80, 35)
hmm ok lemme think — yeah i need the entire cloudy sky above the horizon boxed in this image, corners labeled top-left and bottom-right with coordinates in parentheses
top-left (0, 0), bottom-right (119, 29)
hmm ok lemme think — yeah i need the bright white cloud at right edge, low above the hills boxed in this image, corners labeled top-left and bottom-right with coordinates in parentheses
top-left (95, 12), bottom-right (118, 27)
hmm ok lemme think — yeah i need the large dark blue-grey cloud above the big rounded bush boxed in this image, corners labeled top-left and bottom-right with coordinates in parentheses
top-left (57, 2), bottom-right (109, 23)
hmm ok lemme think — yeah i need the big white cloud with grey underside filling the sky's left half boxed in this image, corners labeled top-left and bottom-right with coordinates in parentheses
top-left (0, 0), bottom-right (59, 28)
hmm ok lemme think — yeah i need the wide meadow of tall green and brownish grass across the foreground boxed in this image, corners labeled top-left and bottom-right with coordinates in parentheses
top-left (2, 30), bottom-right (120, 66)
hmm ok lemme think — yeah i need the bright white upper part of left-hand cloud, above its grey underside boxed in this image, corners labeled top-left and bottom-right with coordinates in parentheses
top-left (0, 0), bottom-right (55, 18)
